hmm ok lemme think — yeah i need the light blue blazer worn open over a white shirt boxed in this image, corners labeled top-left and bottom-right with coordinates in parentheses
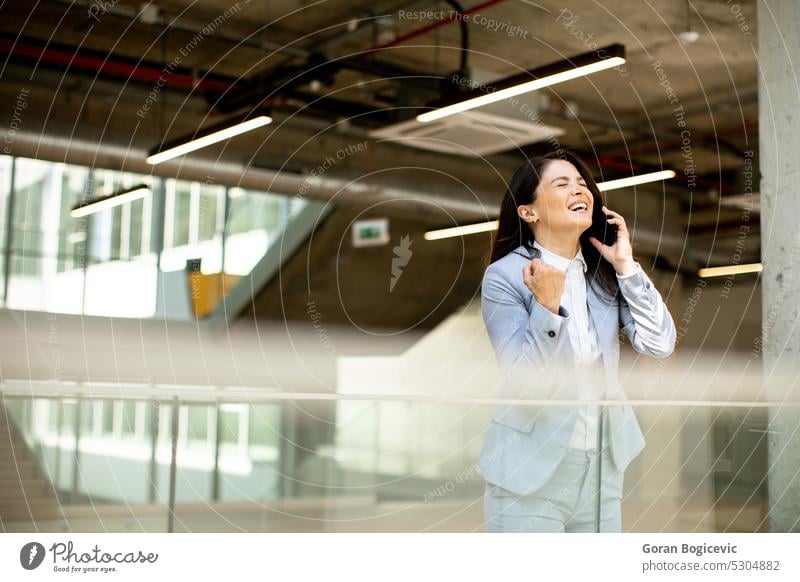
top-left (477, 245), bottom-right (676, 495)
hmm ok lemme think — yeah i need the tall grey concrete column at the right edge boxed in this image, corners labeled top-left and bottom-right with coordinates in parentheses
top-left (758, 0), bottom-right (800, 532)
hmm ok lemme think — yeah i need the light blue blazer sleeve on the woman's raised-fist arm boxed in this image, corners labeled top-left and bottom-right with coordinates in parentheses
top-left (481, 264), bottom-right (569, 397)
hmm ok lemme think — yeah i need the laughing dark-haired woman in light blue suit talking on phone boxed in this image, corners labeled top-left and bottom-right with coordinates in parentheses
top-left (478, 150), bottom-right (675, 532)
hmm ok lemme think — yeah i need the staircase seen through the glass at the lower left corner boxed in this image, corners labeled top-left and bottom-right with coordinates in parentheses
top-left (0, 405), bottom-right (60, 531)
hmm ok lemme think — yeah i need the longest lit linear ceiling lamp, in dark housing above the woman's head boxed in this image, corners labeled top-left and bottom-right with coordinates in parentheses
top-left (417, 44), bottom-right (625, 123)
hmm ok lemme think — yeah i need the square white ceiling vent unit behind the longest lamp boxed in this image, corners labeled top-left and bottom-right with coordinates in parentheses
top-left (369, 111), bottom-right (564, 157)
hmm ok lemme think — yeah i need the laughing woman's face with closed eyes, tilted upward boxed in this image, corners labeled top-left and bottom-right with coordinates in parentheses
top-left (517, 160), bottom-right (594, 236)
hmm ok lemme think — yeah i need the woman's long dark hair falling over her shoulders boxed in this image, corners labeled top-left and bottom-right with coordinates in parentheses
top-left (488, 149), bottom-right (619, 301)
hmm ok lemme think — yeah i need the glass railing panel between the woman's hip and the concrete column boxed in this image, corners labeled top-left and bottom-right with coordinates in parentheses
top-left (622, 406), bottom-right (778, 532)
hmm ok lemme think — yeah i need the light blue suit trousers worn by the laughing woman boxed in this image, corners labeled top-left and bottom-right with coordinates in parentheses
top-left (483, 446), bottom-right (623, 533)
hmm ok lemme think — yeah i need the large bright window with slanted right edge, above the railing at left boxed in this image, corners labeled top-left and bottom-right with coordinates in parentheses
top-left (0, 156), bottom-right (307, 319)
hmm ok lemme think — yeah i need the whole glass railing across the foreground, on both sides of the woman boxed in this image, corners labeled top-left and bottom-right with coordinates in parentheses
top-left (0, 391), bottom-right (799, 532)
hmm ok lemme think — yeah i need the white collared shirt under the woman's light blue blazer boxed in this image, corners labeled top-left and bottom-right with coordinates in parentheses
top-left (533, 242), bottom-right (607, 450)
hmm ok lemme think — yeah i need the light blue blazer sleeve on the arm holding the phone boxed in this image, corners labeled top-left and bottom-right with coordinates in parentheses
top-left (617, 263), bottom-right (676, 358)
